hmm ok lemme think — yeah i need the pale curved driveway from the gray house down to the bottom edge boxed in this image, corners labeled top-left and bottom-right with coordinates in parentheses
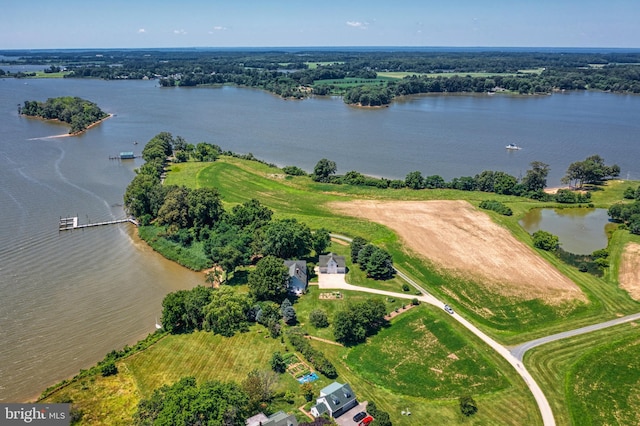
top-left (328, 234), bottom-right (556, 426)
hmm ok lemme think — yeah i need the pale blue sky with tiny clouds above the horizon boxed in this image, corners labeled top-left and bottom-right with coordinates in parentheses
top-left (0, 0), bottom-right (640, 49)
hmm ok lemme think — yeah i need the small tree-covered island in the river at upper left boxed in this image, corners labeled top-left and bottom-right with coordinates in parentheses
top-left (18, 96), bottom-right (109, 135)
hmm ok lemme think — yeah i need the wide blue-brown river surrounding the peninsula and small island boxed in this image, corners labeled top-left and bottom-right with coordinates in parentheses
top-left (0, 79), bottom-right (640, 402)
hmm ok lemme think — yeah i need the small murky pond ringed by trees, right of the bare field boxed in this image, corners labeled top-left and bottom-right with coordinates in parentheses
top-left (520, 208), bottom-right (609, 254)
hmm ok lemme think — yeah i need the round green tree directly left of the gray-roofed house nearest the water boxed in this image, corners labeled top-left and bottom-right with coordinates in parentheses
top-left (247, 256), bottom-right (289, 301)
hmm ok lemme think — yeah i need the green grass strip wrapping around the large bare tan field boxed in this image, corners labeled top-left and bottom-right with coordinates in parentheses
top-left (166, 157), bottom-right (640, 344)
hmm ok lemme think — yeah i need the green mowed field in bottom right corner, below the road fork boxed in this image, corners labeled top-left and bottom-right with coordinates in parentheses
top-left (525, 323), bottom-right (640, 426)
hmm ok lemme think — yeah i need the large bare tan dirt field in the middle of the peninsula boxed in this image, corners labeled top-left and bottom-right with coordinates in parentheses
top-left (331, 200), bottom-right (586, 304)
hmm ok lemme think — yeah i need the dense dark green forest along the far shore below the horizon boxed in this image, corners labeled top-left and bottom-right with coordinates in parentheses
top-left (0, 49), bottom-right (640, 106)
